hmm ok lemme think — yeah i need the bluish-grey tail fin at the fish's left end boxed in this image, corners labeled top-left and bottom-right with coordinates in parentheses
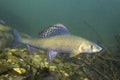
top-left (13, 29), bottom-right (21, 47)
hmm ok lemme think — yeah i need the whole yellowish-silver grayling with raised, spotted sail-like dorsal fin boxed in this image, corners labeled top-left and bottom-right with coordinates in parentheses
top-left (13, 24), bottom-right (102, 61)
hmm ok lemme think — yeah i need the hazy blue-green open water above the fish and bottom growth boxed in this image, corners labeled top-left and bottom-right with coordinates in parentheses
top-left (0, 0), bottom-right (120, 43)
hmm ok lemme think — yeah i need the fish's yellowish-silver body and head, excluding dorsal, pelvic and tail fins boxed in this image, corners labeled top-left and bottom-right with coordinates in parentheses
top-left (20, 34), bottom-right (102, 57)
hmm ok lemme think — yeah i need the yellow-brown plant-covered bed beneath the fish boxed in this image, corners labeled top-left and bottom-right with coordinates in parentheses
top-left (0, 22), bottom-right (120, 80)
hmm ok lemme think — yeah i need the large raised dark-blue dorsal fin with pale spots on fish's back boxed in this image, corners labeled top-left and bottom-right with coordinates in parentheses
top-left (39, 24), bottom-right (70, 38)
